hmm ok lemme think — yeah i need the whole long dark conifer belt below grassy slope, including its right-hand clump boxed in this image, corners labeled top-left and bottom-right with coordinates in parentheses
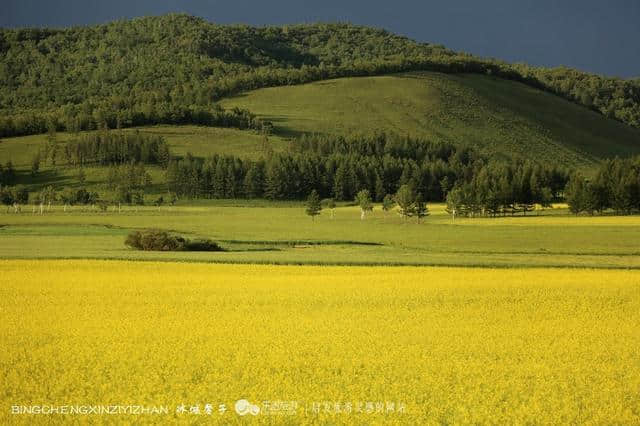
top-left (166, 134), bottom-right (568, 207)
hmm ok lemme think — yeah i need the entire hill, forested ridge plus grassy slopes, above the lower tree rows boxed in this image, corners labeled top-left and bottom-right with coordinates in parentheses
top-left (0, 15), bottom-right (640, 192)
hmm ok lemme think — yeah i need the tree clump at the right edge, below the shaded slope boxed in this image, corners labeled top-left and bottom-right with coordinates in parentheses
top-left (565, 156), bottom-right (640, 214)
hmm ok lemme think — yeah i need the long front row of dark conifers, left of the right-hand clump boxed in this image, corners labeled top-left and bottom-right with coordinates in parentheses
top-left (166, 154), bottom-right (473, 201)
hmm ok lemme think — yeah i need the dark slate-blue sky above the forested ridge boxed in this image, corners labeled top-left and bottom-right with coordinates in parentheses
top-left (0, 0), bottom-right (640, 77)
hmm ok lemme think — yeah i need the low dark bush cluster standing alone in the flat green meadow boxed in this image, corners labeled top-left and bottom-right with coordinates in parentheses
top-left (124, 229), bottom-right (222, 251)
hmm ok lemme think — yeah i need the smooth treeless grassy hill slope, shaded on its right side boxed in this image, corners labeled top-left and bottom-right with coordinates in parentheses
top-left (221, 72), bottom-right (640, 166)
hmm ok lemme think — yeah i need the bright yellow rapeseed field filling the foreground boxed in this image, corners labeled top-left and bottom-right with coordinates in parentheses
top-left (0, 260), bottom-right (640, 424)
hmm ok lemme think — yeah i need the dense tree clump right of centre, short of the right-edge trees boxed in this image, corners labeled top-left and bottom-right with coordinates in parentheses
top-left (446, 162), bottom-right (568, 219)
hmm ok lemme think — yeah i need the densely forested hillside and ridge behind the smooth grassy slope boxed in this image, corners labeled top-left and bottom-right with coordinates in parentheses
top-left (0, 14), bottom-right (640, 136)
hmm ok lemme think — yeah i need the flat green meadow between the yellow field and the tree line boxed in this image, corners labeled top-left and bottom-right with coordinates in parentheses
top-left (0, 201), bottom-right (640, 268)
